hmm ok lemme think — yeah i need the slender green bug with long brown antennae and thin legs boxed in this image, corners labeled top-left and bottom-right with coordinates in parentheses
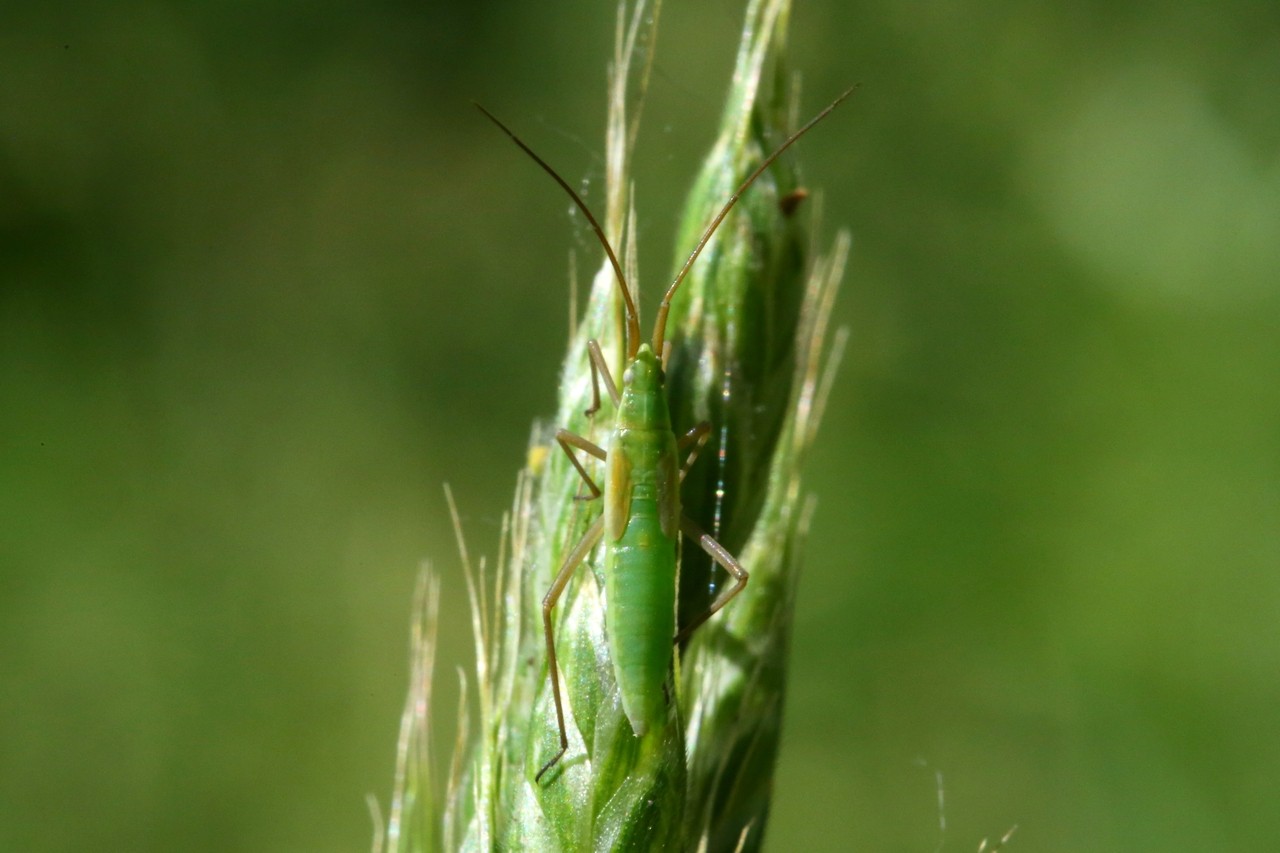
top-left (476, 88), bottom-right (854, 783)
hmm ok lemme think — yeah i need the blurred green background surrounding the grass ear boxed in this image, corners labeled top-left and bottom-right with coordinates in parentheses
top-left (0, 0), bottom-right (1280, 852)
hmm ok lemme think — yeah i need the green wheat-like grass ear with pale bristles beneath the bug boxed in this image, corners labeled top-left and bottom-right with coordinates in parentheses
top-left (375, 0), bottom-right (849, 853)
